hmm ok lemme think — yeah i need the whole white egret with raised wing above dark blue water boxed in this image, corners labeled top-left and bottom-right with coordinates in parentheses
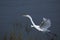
top-left (23, 15), bottom-right (51, 32)
